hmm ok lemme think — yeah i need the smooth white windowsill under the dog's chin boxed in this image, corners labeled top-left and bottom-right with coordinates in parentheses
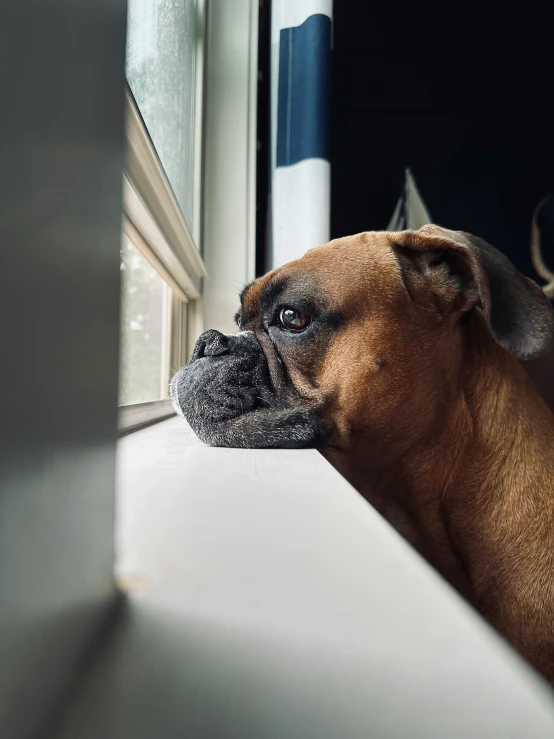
top-left (54, 418), bottom-right (554, 739)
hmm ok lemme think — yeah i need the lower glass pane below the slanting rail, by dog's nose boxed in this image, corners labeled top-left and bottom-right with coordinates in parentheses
top-left (119, 235), bottom-right (170, 405)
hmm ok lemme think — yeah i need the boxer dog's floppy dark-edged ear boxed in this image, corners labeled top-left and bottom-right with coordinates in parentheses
top-left (390, 225), bottom-right (554, 359)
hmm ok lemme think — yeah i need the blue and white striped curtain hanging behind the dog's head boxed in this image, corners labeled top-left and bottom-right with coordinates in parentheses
top-left (268, 0), bottom-right (333, 267)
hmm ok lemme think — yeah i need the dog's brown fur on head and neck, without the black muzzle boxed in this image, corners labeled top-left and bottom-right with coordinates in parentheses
top-left (243, 233), bottom-right (554, 681)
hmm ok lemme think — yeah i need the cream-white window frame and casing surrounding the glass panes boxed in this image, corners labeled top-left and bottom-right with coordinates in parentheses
top-left (119, 0), bottom-right (259, 433)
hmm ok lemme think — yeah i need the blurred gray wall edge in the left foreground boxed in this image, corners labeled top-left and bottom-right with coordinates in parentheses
top-left (0, 0), bottom-right (126, 739)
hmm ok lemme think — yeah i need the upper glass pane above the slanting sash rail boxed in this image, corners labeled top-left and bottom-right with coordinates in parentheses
top-left (126, 0), bottom-right (196, 230)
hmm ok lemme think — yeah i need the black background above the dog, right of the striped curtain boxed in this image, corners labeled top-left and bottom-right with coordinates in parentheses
top-left (331, 0), bottom-right (554, 277)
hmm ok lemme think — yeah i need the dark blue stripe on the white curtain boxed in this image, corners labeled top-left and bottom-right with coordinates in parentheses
top-left (277, 13), bottom-right (331, 167)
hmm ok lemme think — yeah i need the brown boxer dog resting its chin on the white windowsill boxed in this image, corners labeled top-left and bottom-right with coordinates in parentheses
top-left (171, 226), bottom-right (554, 681)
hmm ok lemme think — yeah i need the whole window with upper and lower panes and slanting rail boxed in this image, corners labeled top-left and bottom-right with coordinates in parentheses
top-left (119, 0), bottom-right (206, 431)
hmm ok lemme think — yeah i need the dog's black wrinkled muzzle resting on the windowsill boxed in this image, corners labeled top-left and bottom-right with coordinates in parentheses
top-left (171, 330), bottom-right (332, 449)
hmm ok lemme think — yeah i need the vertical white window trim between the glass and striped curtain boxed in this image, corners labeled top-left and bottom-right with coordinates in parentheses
top-left (202, 0), bottom-right (259, 333)
